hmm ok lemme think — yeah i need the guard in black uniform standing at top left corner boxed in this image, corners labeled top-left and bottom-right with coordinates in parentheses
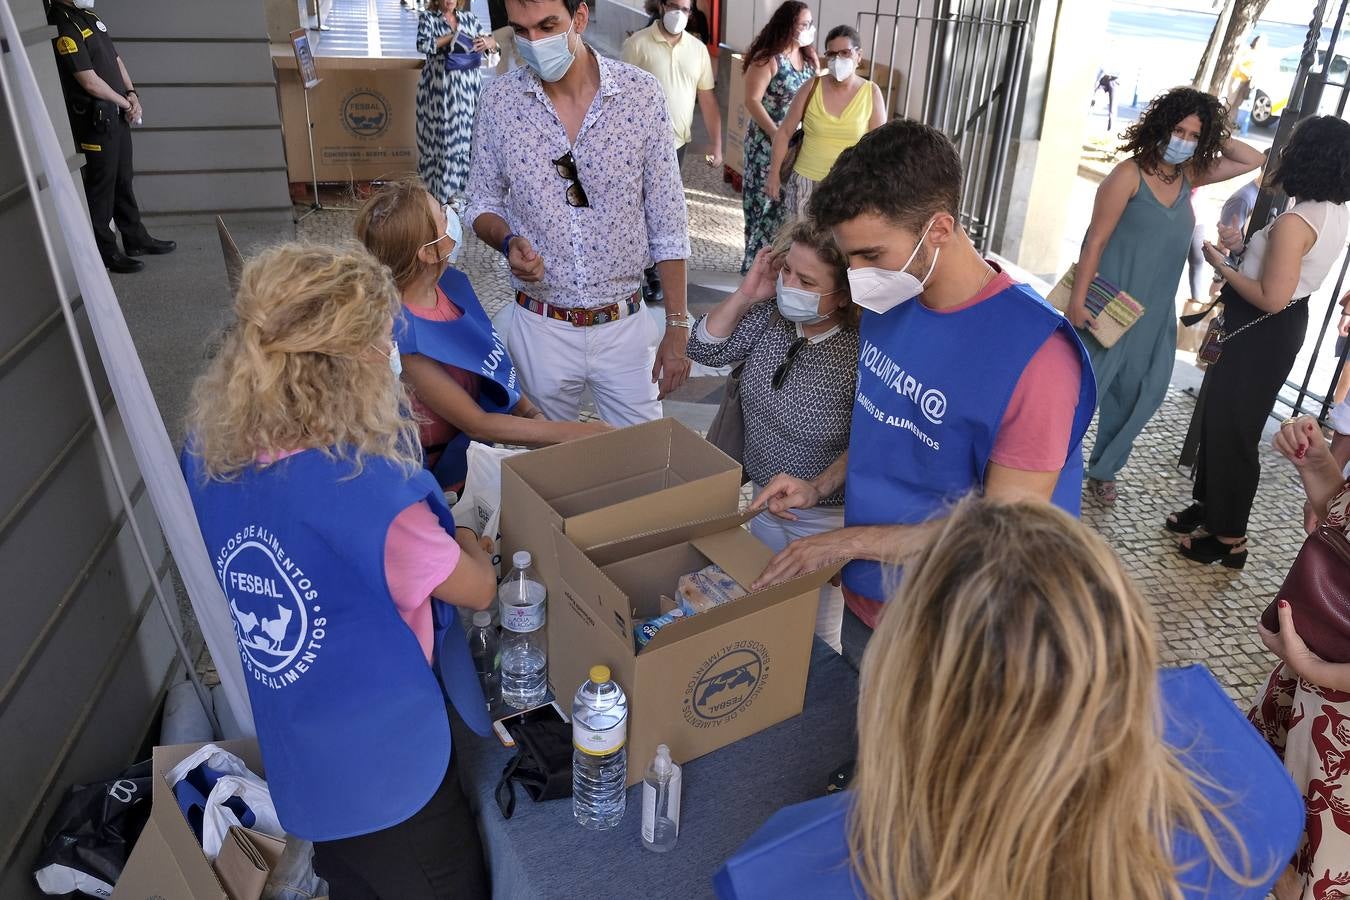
top-left (47, 0), bottom-right (177, 273)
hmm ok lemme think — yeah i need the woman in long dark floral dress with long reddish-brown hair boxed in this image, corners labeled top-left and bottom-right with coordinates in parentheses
top-left (741, 0), bottom-right (819, 275)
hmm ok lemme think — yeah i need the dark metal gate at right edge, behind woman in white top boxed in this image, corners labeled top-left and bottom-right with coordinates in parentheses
top-left (1247, 0), bottom-right (1350, 422)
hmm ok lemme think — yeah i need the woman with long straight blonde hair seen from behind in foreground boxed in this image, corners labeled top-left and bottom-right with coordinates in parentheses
top-left (714, 499), bottom-right (1303, 900)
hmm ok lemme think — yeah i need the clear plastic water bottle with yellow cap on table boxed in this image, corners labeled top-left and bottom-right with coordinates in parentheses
top-left (572, 665), bottom-right (628, 831)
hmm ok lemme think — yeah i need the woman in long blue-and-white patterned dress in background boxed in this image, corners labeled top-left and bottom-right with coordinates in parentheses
top-left (417, 0), bottom-right (497, 202)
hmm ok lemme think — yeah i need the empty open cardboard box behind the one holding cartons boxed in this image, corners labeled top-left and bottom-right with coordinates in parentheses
top-left (501, 418), bottom-right (741, 604)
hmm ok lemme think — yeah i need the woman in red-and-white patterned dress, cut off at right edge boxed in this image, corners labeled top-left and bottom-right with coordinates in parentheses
top-left (1247, 416), bottom-right (1350, 900)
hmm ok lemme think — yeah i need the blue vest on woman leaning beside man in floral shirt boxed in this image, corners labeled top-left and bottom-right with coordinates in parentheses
top-left (397, 267), bottom-right (520, 487)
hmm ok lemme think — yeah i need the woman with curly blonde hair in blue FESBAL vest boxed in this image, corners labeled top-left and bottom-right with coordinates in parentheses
top-left (182, 244), bottom-right (495, 899)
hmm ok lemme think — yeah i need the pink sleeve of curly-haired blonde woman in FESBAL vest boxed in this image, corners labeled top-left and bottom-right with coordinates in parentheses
top-left (385, 501), bottom-right (460, 663)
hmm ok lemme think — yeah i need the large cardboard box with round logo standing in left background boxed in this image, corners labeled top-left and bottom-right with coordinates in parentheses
top-left (273, 52), bottom-right (421, 182)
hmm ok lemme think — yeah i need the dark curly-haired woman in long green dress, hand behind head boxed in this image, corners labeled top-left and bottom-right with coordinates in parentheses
top-left (1065, 88), bottom-right (1264, 503)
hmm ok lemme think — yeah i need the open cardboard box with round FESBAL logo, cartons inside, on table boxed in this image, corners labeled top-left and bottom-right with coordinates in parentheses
top-left (548, 513), bottom-right (838, 785)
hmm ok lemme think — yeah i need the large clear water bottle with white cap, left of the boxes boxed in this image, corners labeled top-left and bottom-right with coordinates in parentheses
top-left (497, 551), bottom-right (548, 710)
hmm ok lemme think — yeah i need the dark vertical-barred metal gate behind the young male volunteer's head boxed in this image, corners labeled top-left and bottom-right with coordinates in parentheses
top-left (857, 0), bottom-right (1031, 252)
